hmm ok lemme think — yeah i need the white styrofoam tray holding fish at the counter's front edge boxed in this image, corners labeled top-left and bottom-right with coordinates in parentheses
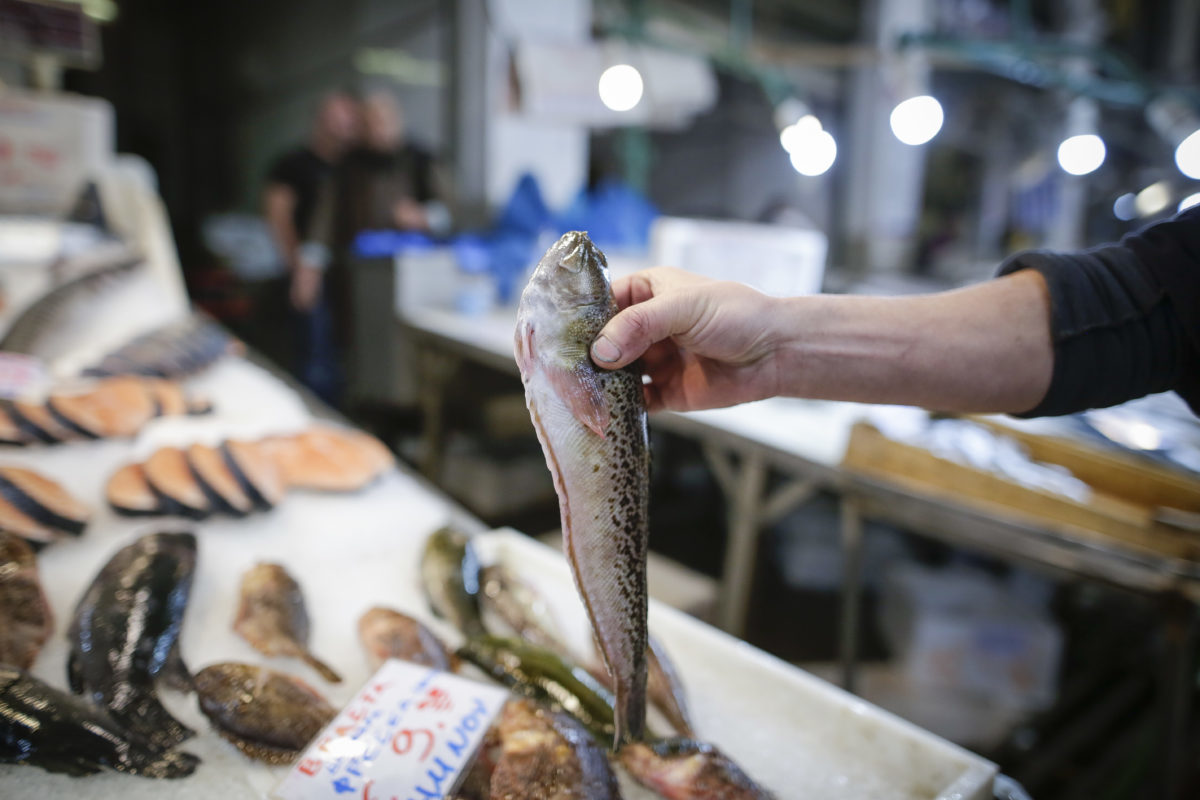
top-left (476, 530), bottom-right (996, 800)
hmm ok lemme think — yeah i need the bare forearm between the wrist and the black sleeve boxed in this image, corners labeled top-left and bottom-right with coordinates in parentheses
top-left (776, 272), bottom-right (1054, 413)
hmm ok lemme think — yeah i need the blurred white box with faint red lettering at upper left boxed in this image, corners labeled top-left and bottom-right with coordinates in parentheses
top-left (0, 89), bottom-right (114, 215)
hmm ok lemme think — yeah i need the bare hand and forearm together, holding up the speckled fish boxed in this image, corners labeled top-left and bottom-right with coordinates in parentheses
top-left (590, 267), bottom-right (1055, 413)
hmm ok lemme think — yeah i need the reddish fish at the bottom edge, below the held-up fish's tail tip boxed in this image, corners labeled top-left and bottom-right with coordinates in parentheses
top-left (618, 739), bottom-right (774, 800)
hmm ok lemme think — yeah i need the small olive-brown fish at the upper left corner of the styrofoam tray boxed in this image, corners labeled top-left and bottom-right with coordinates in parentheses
top-left (421, 528), bottom-right (485, 637)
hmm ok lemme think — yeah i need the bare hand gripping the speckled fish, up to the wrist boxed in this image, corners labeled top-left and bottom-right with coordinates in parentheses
top-left (592, 266), bottom-right (784, 411)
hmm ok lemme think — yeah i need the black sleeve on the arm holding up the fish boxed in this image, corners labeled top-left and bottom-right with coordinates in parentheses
top-left (998, 207), bottom-right (1200, 416)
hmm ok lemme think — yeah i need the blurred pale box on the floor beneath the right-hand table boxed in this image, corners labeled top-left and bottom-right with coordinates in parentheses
top-left (880, 563), bottom-right (1063, 709)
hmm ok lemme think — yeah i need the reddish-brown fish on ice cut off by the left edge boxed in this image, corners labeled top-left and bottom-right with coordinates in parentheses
top-left (0, 530), bottom-right (54, 669)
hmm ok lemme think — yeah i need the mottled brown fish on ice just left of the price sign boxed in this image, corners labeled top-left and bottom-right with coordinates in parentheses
top-left (196, 662), bottom-right (337, 764)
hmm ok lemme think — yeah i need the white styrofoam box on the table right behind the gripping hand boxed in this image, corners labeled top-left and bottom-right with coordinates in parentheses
top-left (650, 217), bottom-right (829, 297)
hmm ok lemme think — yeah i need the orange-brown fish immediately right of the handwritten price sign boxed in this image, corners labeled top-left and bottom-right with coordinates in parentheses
top-left (490, 699), bottom-right (620, 800)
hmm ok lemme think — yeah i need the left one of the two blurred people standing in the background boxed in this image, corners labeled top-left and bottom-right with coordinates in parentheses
top-left (263, 92), bottom-right (360, 404)
